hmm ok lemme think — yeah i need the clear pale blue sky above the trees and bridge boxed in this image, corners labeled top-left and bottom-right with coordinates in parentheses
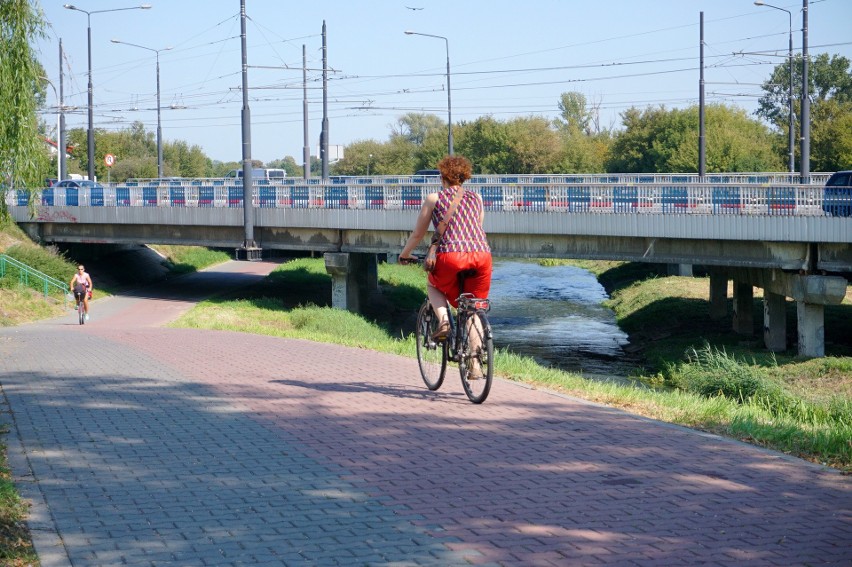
top-left (39, 0), bottom-right (852, 163)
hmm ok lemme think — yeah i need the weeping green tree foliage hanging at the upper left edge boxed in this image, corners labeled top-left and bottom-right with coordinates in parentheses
top-left (0, 0), bottom-right (46, 211)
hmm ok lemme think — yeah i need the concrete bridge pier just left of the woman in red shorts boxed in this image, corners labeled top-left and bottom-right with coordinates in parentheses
top-left (324, 252), bottom-right (379, 313)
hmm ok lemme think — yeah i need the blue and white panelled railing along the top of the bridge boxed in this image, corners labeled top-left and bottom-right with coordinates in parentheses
top-left (5, 179), bottom-right (852, 216)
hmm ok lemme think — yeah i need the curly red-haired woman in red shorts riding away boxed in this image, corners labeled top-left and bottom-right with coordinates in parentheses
top-left (399, 156), bottom-right (491, 347)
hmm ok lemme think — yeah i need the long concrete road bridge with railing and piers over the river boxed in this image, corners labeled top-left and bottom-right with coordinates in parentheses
top-left (6, 176), bottom-right (852, 356)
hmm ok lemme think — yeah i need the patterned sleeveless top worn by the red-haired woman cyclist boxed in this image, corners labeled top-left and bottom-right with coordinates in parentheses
top-left (432, 187), bottom-right (491, 252)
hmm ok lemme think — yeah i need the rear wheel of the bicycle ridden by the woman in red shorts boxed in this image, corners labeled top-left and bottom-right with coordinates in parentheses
top-left (459, 312), bottom-right (494, 404)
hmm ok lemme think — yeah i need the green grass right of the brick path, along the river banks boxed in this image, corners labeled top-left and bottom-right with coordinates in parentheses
top-left (168, 259), bottom-right (852, 470)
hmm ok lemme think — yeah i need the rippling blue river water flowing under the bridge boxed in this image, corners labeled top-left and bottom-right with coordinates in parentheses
top-left (489, 260), bottom-right (634, 377)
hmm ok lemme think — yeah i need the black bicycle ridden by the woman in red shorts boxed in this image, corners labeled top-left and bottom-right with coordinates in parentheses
top-left (404, 256), bottom-right (494, 404)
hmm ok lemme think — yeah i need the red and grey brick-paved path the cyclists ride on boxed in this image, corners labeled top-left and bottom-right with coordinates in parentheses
top-left (0, 262), bottom-right (852, 567)
